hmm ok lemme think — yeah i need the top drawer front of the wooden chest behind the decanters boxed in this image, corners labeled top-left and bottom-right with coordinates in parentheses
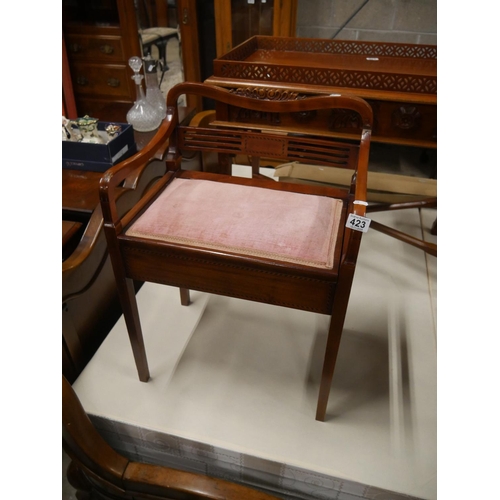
top-left (66, 35), bottom-right (124, 62)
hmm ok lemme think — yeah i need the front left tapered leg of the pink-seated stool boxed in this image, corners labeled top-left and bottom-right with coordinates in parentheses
top-left (118, 278), bottom-right (149, 382)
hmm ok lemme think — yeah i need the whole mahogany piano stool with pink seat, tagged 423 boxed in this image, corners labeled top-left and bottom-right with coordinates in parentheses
top-left (100, 83), bottom-right (372, 420)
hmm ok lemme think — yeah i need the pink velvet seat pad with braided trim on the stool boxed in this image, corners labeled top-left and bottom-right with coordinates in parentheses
top-left (126, 179), bottom-right (342, 269)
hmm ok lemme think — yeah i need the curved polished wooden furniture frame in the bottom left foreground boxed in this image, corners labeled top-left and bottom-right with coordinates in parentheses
top-left (62, 377), bottom-right (277, 500)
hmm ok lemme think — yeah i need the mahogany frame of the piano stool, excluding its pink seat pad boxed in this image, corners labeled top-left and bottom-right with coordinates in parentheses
top-left (100, 83), bottom-right (373, 420)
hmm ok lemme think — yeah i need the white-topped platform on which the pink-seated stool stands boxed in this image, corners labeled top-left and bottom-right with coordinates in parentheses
top-left (74, 197), bottom-right (437, 500)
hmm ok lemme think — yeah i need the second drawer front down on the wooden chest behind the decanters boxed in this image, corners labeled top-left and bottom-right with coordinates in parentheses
top-left (71, 63), bottom-right (134, 98)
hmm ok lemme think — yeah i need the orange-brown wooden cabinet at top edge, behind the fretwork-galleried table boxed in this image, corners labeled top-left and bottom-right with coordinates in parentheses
top-left (214, 0), bottom-right (297, 57)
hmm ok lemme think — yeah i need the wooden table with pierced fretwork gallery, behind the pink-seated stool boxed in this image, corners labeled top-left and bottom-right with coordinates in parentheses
top-left (206, 36), bottom-right (437, 148)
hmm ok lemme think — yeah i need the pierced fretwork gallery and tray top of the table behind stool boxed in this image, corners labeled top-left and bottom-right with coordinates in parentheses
top-left (214, 36), bottom-right (437, 94)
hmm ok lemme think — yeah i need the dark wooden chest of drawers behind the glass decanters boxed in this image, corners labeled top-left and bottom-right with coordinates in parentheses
top-left (63, 0), bottom-right (141, 122)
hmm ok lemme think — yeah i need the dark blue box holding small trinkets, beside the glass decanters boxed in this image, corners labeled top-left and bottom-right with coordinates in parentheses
top-left (62, 122), bottom-right (137, 172)
